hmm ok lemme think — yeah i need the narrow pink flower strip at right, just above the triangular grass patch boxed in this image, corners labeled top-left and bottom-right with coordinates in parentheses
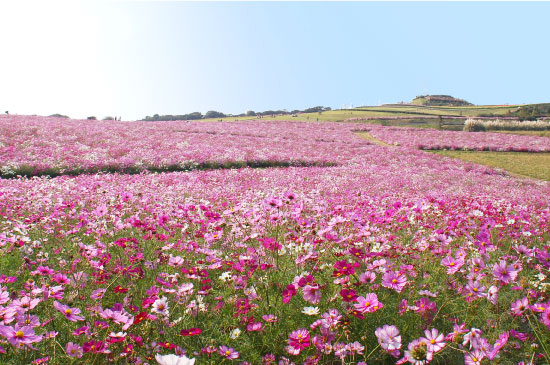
top-left (369, 126), bottom-right (550, 152)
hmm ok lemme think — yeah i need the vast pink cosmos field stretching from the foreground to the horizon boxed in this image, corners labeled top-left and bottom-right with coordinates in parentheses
top-left (0, 117), bottom-right (550, 364)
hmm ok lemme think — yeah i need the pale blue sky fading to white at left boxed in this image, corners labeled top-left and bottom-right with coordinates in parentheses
top-left (0, 0), bottom-right (550, 120)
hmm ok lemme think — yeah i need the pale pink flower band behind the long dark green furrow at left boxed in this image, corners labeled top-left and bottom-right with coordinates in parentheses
top-left (0, 116), bottom-right (374, 176)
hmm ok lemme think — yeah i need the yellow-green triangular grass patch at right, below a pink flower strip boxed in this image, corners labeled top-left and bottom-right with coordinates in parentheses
top-left (434, 151), bottom-right (550, 181)
